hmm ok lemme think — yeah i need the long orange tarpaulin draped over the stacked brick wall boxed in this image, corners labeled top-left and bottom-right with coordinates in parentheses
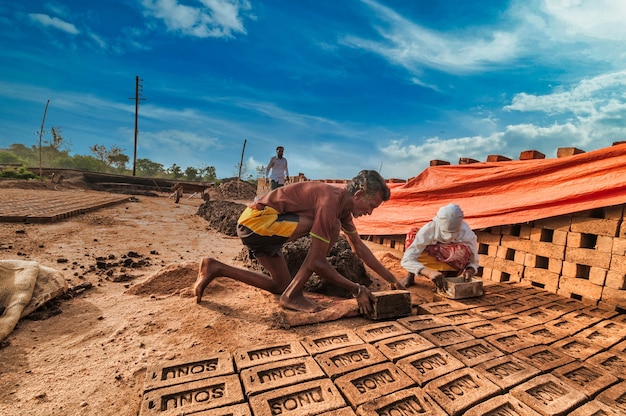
top-left (355, 144), bottom-right (626, 235)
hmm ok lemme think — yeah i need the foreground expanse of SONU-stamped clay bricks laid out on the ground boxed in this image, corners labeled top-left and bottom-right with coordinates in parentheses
top-left (140, 283), bottom-right (626, 416)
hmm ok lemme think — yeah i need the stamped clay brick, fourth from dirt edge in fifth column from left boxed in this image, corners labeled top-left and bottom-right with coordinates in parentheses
top-left (475, 354), bottom-right (541, 391)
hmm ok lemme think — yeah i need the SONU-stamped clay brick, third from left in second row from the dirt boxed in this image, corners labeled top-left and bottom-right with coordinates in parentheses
top-left (315, 344), bottom-right (387, 379)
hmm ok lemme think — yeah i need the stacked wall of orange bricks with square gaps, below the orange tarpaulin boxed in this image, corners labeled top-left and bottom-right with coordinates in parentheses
top-left (476, 205), bottom-right (626, 310)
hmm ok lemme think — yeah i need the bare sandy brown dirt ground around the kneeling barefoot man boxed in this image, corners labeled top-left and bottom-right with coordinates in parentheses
top-left (0, 181), bottom-right (432, 416)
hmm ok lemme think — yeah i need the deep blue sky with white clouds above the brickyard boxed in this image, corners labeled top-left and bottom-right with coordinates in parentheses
top-left (0, 0), bottom-right (626, 179)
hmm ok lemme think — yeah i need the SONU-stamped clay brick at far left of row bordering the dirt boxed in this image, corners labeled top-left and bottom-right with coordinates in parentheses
top-left (143, 353), bottom-right (235, 392)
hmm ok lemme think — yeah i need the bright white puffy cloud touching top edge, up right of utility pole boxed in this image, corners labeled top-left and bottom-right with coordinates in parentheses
top-left (142, 0), bottom-right (250, 38)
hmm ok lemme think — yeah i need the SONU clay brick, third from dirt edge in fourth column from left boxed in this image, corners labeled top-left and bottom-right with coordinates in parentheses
top-left (396, 348), bottom-right (464, 387)
